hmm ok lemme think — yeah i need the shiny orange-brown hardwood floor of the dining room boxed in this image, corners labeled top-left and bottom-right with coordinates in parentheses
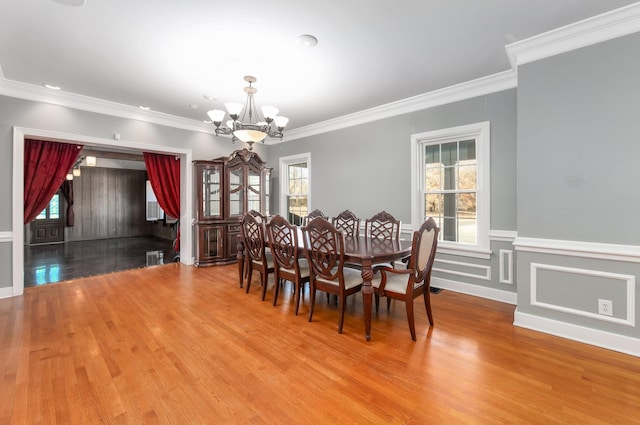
top-left (0, 263), bottom-right (640, 425)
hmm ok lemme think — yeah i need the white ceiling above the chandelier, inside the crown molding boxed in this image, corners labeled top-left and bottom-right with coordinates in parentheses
top-left (0, 0), bottom-right (635, 129)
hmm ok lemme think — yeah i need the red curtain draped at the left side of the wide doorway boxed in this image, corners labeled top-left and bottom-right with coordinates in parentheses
top-left (24, 139), bottom-right (82, 224)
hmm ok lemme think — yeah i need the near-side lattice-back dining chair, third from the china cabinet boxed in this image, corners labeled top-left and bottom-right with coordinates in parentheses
top-left (302, 217), bottom-right (363, 334)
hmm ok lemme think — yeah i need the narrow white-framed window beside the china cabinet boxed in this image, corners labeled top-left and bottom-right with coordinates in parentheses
top-left (280, 153), bottom-right (311, 225)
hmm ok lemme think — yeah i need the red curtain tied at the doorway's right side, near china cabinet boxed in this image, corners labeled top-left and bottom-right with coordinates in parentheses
top-left (143, 152), bottom-right (180, 251)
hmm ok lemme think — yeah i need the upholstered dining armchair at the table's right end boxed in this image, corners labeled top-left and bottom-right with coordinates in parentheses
top-left (371, 217), bottom-right (440, 341)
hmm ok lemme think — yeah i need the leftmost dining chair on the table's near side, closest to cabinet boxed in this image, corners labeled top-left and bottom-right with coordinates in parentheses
top-left (242, 213), bottom-right (277, 301)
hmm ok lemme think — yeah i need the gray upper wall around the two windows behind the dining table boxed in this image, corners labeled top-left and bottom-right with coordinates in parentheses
top-left (270, 89), bottom-right (516, 230)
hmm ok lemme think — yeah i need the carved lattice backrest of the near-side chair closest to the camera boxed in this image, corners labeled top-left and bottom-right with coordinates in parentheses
top-left (302, 217), bottom-right (344, 285)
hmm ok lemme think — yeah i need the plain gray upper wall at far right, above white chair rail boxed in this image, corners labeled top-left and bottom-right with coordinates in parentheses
top-left (518, 34), bottom-right (640, 245)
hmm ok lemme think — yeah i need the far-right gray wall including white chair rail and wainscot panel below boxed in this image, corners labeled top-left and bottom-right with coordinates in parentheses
top-left (516, 34), bottom-right (640, 342)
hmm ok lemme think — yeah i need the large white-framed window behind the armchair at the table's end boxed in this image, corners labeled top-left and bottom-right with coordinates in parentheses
top-left (411, 122), bottom-right (490, 258)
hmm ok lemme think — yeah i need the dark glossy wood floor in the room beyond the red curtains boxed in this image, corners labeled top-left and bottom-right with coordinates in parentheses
top-left (24, 236), bottom-right (174, 287)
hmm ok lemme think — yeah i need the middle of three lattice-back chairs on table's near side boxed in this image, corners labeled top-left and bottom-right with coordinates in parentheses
top-left (267, 215), bottom-right (310, 315)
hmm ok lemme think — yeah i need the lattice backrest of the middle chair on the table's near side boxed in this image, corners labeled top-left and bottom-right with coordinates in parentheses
top-left (267, 215), bottom-right (299, 272)
